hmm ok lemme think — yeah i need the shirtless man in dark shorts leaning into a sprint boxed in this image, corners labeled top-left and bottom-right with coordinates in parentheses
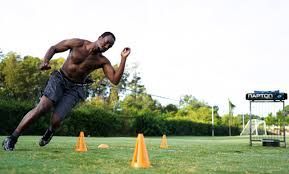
top-left (2, 32), bottom-right (130, 151)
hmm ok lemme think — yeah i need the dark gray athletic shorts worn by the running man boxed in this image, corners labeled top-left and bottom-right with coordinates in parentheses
top-left (43, 71), bottom-right (85, 120)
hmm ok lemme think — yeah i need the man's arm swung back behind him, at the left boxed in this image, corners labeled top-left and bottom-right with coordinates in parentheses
top-left (40, 39), bottom-right (82, 70)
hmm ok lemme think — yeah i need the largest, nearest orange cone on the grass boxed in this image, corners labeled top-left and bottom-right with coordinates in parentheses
top-left (131, 134), bottom-right (150, 168)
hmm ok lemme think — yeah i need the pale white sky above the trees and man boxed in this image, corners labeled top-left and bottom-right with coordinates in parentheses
top-left (0, 0), bottom-right (289, 115)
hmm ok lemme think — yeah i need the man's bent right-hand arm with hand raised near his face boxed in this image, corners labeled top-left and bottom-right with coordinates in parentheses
top-left (103, 48), bottom-right (130, 85)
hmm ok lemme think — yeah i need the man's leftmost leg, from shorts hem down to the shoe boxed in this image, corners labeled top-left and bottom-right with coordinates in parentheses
top-left (2, 96), bottom-right (53, 151)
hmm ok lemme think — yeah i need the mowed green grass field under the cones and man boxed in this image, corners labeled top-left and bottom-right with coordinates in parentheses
top-left (0, 136), bottom-right (289, 174)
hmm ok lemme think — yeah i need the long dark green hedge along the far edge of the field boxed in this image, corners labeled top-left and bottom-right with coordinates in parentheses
top-left (0, 99), bottom-right (240, 136)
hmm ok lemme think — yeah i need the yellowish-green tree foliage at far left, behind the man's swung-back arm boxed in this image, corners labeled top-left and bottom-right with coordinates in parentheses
top-left (0, 52), bottom-right (64, 102)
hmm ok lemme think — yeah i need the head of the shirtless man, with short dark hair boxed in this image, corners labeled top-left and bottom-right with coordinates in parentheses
top-left (96, 32), bottom-right (115, 52)
